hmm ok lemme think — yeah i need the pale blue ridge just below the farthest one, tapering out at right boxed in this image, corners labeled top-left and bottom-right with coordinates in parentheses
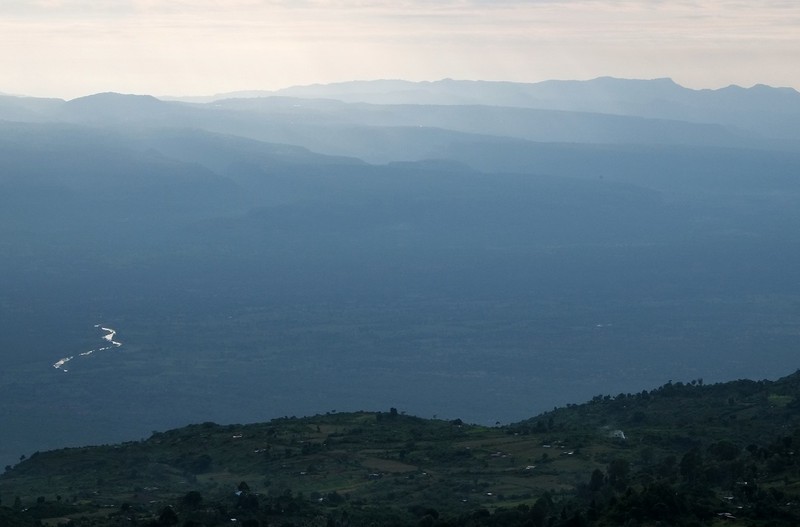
top-left (208, 98), bottom-right (775, 162)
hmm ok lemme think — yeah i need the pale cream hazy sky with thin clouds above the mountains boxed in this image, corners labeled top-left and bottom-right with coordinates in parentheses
top-left (0, 0), bottom-right (800, 98)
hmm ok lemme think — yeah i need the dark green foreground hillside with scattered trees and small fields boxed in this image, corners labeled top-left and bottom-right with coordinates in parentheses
top-left (0, 373), bottom-right (800, 526)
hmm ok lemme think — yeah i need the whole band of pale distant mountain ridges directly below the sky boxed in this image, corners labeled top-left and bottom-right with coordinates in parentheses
top-left (0, 78), bottom-right (800, 162)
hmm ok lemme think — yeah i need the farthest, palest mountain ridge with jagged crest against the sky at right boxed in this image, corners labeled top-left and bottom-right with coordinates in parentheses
top-left (275, 77), bottom-right (800, 140)
